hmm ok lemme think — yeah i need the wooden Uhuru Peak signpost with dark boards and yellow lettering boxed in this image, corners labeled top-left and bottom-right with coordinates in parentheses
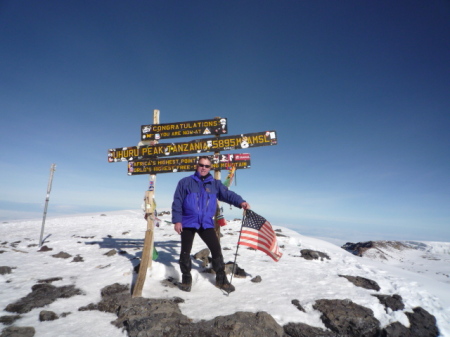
top-left (108, 110), bottom-right (277, 297)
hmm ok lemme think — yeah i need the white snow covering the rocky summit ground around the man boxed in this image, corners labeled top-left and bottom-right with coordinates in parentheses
top-left (0, 210), bottom-right (450, 337)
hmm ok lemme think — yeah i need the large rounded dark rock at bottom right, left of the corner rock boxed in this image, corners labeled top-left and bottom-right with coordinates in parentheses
top-left (313, 299), bottom-right (380, 337)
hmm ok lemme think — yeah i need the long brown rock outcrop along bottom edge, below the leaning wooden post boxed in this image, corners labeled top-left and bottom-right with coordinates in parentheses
top-left (79, 284), bottom-right (284, 337)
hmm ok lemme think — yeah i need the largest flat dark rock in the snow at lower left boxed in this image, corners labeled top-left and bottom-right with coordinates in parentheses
top-left (5, 284), bottom-right (82, 314)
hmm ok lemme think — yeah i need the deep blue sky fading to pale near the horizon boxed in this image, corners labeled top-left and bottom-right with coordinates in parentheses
top-left (0, 0), bottom-right (450, 241)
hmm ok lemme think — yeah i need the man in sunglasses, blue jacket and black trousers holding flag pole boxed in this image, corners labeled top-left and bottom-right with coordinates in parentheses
top-left (172, 156), bottom-right (250, 293)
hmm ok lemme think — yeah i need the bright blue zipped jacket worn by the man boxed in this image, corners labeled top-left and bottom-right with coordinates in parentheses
top-left (172, 172), bottom-right (244, 229)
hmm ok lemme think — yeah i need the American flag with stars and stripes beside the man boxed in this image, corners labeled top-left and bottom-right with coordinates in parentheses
top-left (238, 210), bottom-right (283, 262)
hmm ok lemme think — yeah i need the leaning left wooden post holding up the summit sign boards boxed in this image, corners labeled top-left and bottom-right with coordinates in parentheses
top-left (133, 110), bottom-right (159, 297)
